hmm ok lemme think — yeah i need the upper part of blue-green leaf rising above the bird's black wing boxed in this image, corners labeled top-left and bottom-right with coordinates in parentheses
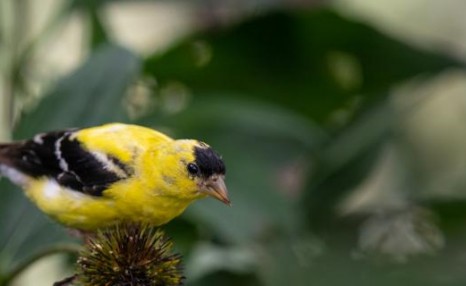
top-left (15, 45), bottom-right (139, 137)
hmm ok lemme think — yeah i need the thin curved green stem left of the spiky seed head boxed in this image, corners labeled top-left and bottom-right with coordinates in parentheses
top-left (0, 244), bottom-right (81, 286)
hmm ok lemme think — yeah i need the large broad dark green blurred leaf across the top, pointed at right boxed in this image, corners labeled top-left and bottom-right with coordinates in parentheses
top-left (145, 9), bottom-right (461, 123)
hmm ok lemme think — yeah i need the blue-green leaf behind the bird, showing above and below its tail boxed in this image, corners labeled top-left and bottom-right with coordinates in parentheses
top-left (0, 46), bottom-right (139, 276)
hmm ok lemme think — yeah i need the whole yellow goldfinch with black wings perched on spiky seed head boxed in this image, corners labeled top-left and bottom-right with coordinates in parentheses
top-left (0, 123), bottom-right (230, 231)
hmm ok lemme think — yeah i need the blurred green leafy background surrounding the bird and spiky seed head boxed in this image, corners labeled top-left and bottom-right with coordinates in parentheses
top-left (0, 0), bottom-right (466, 286)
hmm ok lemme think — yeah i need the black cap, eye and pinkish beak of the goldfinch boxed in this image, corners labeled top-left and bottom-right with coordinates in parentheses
top-left (187, 142), bottom-right (230, 205)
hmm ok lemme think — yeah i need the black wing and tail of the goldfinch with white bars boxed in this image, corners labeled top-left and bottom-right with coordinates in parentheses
top-left (0, 130), bottom-right (133, 196)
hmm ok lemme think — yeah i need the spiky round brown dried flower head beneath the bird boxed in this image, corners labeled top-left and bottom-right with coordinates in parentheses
top-left (77, 224), bottom-right (184, 286)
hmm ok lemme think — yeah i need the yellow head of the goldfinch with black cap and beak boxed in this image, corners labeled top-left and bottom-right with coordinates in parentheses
top-left (155, 140), bottom-right (230, 205)
